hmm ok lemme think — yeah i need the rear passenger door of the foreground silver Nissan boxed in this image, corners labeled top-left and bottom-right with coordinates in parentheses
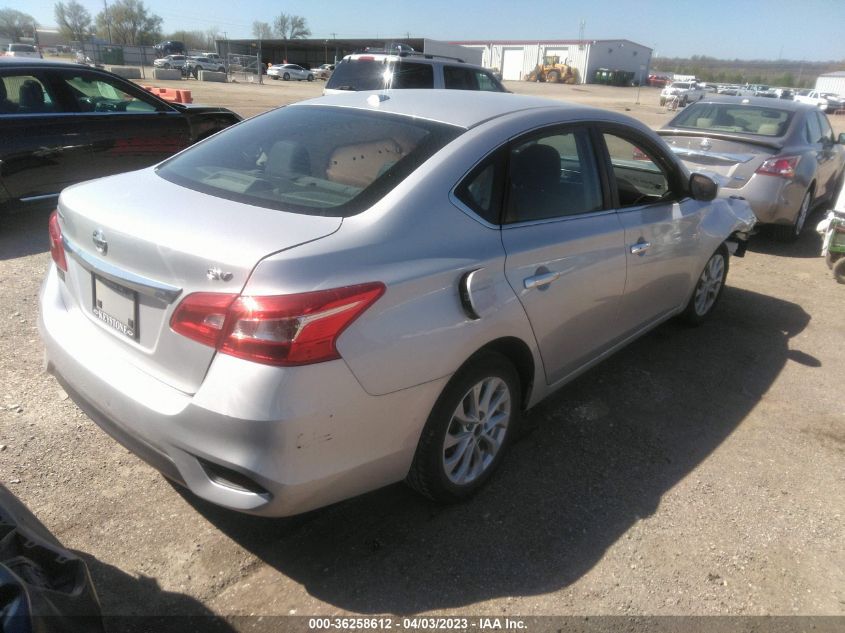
top-left (502, 122), bottom-right (625, 384)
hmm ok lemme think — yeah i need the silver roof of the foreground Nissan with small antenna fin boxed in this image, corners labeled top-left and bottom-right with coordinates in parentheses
top-left (296, 88), bottom-right (628, 129)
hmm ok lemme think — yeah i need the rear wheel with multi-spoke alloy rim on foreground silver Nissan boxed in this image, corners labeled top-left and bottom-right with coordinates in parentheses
top-left (405, 352), bottom-right (521, 503)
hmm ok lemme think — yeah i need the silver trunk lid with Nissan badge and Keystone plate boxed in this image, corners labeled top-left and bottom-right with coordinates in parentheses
top-left (59, 169), bottom-right (342, 393)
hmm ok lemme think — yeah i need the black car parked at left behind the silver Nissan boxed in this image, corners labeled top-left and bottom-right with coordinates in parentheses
top-left (0, 57), bottom-right (241, 213)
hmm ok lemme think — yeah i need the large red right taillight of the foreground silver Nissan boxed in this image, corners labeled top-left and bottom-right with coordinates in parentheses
top-left (170, 282), bottom-right (384, 366)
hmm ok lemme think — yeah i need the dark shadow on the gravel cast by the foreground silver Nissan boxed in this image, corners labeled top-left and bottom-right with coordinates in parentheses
top-left (173, 287), bottom-right (820, 614)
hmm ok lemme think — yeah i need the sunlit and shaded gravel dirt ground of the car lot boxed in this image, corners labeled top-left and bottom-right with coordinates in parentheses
top-left (0, 82), bottom-right (845, 630)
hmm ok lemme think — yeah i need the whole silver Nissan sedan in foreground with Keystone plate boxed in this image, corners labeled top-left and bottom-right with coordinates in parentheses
top-left (40, 90), bottom-right (754, 516)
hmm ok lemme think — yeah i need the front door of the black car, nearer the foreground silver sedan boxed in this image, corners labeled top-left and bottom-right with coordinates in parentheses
top-left (52, 68), bottom-right (191, 178)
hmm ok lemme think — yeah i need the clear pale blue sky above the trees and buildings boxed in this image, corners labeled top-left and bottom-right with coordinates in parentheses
top-left (11, 0), bottom-right (845, 64)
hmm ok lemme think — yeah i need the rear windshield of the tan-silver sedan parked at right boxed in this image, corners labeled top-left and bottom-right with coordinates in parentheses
top-left (669, 103), bottom-right (793, 137)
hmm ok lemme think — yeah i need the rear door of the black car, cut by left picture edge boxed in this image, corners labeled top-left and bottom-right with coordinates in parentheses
top-left (0, 67), bottom-right (90, 207)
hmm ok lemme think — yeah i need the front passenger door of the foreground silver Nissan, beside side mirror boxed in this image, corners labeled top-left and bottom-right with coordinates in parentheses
top-left (601, 126), bottom-right (702, 336)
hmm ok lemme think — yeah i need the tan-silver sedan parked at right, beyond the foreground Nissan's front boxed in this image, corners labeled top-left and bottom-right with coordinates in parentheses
top-left (659, 97), bottom-right (845, 241)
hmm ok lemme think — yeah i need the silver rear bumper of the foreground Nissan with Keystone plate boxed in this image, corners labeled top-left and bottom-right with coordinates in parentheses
top-left (39, 266), bottom-right (446, 516)
